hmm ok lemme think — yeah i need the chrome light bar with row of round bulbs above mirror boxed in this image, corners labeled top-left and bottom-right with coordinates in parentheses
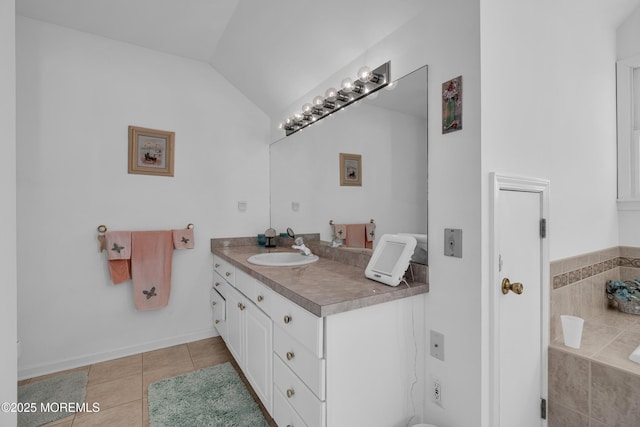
top-left (278, 62), bottom-right (391, 136)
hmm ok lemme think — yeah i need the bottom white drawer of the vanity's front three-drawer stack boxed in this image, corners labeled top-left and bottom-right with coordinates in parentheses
top-left (273, 357), bottom-right (326, 427)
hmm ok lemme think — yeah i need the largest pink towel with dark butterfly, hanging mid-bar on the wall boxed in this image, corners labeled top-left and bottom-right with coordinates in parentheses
top-left (131, 230), bottom-right (173, 310)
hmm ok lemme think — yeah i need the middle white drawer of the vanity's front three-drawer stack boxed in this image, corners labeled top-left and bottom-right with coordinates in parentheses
top-left (273, 327), bottom-right (326, 400)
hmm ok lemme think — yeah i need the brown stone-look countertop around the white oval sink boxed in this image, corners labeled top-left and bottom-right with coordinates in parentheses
top-left (211, 244), bottom-right (429, 317)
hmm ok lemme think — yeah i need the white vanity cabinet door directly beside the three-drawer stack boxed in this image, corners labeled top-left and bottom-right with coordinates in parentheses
top-left (243, 303), bottom-right (273, 414)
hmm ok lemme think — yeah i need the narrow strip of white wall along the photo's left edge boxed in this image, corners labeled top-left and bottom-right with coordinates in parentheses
top-left (0, 0), bottom-right (17, 426)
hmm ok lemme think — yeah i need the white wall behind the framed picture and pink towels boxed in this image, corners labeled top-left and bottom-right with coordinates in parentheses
top-left (15, 15), bottom-right (269, 377)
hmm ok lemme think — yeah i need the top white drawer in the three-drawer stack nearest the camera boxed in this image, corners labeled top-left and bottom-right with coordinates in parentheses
top-left (271, 293), bottom-right (324, 358)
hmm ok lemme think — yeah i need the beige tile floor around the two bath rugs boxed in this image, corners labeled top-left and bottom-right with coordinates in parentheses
top-left (18, 337), bottom-right (276, 427)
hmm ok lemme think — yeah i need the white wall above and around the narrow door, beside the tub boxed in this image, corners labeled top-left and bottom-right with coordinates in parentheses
top-left (479, 0), bottom-right (618, 422)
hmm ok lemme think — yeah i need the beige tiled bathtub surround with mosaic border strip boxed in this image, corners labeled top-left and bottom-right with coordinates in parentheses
top-left (549, 247), bottom-right (640, 427)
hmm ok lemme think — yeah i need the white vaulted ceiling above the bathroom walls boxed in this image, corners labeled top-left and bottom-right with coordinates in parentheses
top-left (16, 0), bottom-right (640, 117)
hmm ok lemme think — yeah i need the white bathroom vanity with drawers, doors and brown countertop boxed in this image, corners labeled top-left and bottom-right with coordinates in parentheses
top-left (211, 239), bottom-right (428, 427)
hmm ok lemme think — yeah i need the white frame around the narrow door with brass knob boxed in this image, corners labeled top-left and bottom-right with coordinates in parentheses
top-left (489, 172), bottom-right (550, 427)
